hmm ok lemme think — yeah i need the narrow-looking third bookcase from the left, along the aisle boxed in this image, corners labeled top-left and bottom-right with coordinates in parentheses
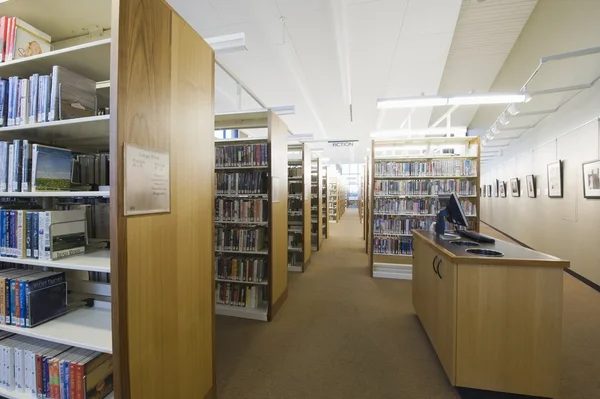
top-left (288, 144), bottom-right (312, 272)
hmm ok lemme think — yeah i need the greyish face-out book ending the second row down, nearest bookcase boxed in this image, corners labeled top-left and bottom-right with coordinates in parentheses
top-left (48, 65), bottom-right (96, 121)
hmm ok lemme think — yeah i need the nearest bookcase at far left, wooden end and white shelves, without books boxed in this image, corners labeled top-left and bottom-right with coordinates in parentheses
top-left (0, 0), bottom-right (215, 398)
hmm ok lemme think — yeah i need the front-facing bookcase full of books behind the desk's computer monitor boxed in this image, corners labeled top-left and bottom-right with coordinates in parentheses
top-left (367, 137), bottom-right (480, 279)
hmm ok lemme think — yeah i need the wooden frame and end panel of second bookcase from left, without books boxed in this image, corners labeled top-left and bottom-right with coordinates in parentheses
top-left (213, 111), bottom-right (288, 321)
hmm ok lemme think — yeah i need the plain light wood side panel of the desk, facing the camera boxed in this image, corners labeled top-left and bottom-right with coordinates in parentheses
top-left (456, 265), bottom-right (563, 398)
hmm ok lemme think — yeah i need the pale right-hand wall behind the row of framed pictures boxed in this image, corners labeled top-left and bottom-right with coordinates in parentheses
top-left (481, 84), bottom-right (600, 284)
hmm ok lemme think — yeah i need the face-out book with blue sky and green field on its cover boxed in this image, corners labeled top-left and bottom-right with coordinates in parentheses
top-left (31, 144), bottom-right (72, 192)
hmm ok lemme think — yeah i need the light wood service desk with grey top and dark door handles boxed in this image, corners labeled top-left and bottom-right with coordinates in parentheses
top-left (412, 230), bottom-right (569, 398)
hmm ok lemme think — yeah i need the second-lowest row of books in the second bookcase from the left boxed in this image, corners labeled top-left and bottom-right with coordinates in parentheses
top-left (215, 256), bottom-right (267, 282)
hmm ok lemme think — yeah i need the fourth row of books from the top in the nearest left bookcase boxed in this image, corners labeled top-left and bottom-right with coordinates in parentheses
top-left (0, 206), bottom-right (87, 260)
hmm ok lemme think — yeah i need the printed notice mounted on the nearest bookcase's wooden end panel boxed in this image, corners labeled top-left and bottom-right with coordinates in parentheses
top-left (123, 144), bottom-right (171, 216)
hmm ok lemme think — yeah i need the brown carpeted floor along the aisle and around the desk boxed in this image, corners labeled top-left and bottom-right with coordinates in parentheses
top-left (216, 209), bottom-right (600, 399)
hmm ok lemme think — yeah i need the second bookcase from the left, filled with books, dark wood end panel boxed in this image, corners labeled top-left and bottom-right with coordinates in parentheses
top-left (214, 111), bottom-right (296, 321)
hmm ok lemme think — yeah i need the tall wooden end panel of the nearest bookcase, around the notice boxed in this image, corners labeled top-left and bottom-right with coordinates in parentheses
top-left (111, 0), bottom-right (214, 399)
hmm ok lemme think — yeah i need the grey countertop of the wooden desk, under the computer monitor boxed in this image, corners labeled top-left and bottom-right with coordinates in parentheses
top-left (412, 230), bottom-right (570, 268)
